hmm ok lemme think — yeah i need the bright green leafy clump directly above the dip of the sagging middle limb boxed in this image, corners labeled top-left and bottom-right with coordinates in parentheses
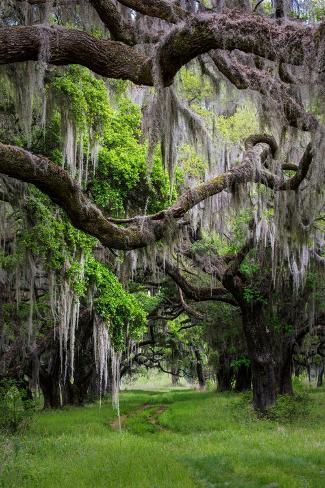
top-left (91, 97), bottom-right (170, 216)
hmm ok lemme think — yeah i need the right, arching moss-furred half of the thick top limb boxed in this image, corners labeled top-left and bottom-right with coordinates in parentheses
top-left (159, 11), bottom-right (324, 83)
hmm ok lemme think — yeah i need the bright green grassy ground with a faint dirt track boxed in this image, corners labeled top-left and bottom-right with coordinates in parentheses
top-left (0, 389), bottom-right (325, 488)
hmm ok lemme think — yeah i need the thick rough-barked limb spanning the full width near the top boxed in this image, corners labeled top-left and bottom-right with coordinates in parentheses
top-left (0, 11), bottom-right (325, 85)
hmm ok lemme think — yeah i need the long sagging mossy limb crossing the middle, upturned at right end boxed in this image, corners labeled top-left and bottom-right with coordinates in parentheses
top-left (0, 136), bottom-right (312, 250)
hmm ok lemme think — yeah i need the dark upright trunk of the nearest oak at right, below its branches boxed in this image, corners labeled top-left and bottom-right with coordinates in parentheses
top-left (242, 304), bottom-right (276, 412)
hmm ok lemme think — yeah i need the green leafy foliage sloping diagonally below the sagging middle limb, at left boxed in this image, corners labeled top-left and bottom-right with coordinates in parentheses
top-left (10, 189), bottom-right (146, 347)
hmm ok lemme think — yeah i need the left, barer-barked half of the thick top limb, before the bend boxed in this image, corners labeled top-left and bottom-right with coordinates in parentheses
top-left (0, 25), bottom-right (152, 85)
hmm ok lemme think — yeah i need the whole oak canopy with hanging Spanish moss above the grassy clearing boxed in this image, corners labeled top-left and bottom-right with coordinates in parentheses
top-left (0, 0), bottom-right (325, 411)
